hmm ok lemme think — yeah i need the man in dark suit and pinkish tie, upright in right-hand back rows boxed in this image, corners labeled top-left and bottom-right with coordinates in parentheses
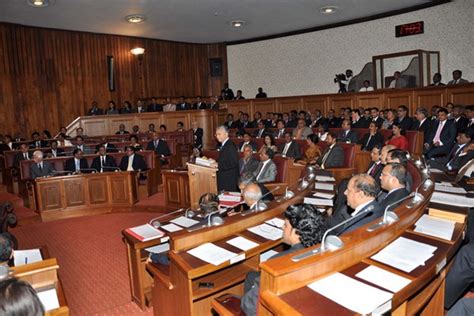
top-left (425, 108), bottom-right (456, 159)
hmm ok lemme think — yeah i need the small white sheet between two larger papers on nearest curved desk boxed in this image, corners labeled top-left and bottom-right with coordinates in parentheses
top-left (356, 266), bottom-right (411, 293)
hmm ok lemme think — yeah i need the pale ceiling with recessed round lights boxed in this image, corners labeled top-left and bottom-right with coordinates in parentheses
top-left (0, 0), bottom-right (436, 43)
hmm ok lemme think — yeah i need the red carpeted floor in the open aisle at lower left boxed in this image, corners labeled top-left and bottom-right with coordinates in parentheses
top-left (11, 212), bottom-right (163, 315)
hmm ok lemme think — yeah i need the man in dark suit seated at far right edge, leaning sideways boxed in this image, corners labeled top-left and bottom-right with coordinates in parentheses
top-left (428, 131), bottom-right (474, 171)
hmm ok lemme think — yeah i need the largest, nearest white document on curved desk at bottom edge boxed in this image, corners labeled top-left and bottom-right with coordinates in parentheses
top-left (308, 273), bottom-right (393, 314)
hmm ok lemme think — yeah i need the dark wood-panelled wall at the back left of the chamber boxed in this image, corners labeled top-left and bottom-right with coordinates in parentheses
top-left (0, 23), bottom-right (227, 135)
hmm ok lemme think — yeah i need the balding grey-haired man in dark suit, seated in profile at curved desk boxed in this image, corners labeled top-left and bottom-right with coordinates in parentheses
top-left (328, 174), bottom-right (383, 234)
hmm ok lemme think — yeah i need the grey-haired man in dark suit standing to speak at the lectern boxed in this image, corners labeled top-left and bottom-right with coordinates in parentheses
top-left (213, 126), bottom-right (239, 191)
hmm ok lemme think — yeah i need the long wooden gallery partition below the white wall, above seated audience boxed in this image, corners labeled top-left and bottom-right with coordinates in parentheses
top-left (222, 84), bottom-right (474, 118)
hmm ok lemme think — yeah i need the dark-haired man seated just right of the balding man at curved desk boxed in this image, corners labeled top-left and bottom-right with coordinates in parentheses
top-left (379, 163), bottom-right (409, 210)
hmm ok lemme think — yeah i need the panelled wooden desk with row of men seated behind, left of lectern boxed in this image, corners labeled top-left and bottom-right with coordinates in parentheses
top-left (34, 171), bottom-right (137, 221)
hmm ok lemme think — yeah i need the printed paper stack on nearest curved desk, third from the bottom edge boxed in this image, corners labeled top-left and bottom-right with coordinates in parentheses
top-left (372, 237), bottom-right (437, 273)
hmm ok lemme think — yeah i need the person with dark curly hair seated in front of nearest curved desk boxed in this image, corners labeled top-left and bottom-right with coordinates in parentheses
top-left (240, 204), bottom-right (327, 316)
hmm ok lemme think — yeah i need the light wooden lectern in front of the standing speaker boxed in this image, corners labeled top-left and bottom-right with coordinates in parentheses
top-left (187, 163), bottom-right (217, 209)
